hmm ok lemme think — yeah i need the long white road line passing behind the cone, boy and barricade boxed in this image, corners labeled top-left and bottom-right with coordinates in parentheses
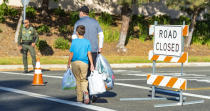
top-left (0, 72), bottom-right (210, 99)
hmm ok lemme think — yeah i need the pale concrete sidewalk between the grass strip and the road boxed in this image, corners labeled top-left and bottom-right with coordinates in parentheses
top-left (0, 62), bottom-right (210, 71)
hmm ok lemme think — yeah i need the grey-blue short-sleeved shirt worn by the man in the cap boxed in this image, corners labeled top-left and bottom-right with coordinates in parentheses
top-left (73, 16), bottom-right (103, 52)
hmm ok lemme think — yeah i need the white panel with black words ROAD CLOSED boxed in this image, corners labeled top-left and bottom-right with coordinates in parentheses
top-left (153, 26), bottom-right (182, 56)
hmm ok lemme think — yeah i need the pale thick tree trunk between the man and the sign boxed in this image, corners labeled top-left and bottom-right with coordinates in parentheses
top-left (117, 4), bottom-right (131, 52)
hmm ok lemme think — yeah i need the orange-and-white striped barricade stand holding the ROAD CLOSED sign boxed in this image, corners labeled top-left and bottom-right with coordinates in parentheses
top-left (120, 22), bottom-right (204, 107)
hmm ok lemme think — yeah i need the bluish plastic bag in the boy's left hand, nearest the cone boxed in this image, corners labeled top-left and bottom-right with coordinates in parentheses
top-left (62, 69), bottom-right (76, 90)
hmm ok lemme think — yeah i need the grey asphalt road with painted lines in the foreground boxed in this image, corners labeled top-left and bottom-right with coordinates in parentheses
top-left (0, 67), bottom-right (210, 111)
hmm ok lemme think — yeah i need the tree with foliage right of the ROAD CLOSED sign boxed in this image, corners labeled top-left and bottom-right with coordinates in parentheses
top-left (167, 0), bottom-right (210, 48)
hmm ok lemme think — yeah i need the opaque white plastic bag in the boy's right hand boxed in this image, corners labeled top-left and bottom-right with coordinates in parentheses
top-left (88, 70), bottom-right (106, 95)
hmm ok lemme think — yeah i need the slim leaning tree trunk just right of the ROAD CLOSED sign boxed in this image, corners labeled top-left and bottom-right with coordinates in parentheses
top-left (186, 8), bottom-right (199, 48)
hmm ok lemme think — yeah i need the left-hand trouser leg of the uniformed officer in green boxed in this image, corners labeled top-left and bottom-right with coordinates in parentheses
top-left (22, 45), bottom-right (28, 73)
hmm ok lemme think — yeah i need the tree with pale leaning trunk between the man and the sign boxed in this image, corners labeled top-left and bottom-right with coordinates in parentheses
top-left (117, 0), bottom-right (159, 52)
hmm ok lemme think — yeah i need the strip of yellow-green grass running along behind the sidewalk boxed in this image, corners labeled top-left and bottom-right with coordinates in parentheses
top-left (0, 56), bottom-right (210, 65)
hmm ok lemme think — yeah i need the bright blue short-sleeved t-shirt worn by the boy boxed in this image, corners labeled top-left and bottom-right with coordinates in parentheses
top-left (69, 38), bottom-right (91, 64)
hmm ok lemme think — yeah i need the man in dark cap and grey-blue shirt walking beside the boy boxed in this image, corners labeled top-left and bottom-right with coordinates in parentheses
top-left (72, 6), bottom-right (104, 102)
